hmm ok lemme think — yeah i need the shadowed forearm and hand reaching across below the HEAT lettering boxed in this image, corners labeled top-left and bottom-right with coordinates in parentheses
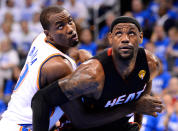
top-left (61, 84), bottom-right (162, 128)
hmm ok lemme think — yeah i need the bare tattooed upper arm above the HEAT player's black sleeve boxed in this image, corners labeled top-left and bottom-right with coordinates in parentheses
top-left (63, 59), bottom-right (105, 99)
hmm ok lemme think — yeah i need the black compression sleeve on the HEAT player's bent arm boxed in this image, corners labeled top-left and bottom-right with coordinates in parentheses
top-left (31, 81), bottom-right (68, 131)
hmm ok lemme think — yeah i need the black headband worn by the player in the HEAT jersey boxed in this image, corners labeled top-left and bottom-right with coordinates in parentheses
top-left (110, 16), bottom-right (142, 32)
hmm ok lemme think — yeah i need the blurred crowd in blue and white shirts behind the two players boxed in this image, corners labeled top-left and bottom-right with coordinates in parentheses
top-left (0, 0), bottom-right (178, 131)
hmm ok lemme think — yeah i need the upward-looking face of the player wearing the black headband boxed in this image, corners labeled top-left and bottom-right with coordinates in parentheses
top-left (109, 23), bottom-right (142, 59)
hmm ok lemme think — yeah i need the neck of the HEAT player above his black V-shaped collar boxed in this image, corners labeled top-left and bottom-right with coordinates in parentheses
top-left (113, 54), bottom-right (136, 79)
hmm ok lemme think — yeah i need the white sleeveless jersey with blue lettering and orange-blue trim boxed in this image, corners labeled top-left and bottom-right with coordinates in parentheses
top-left (2, 33), bottom-right (76, 124)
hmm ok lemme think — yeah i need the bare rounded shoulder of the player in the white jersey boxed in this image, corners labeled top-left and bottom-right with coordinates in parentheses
top-left (41, 56), bottom-right (72, 84)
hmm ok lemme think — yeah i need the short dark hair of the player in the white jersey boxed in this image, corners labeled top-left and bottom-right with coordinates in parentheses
top-left (40, 6), bottom-right (65, 30)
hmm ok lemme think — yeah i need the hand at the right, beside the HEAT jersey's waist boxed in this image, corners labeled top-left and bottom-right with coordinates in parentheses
top-left (135, 95), bottom-right (164, 117)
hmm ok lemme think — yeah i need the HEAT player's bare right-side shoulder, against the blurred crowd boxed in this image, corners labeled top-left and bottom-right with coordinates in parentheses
top-left (145, 50), bottom-right (160, 80)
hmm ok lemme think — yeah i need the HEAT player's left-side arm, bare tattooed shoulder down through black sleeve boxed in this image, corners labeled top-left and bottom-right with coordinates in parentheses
top-left (32, 60), bottom-right (102, 131)
